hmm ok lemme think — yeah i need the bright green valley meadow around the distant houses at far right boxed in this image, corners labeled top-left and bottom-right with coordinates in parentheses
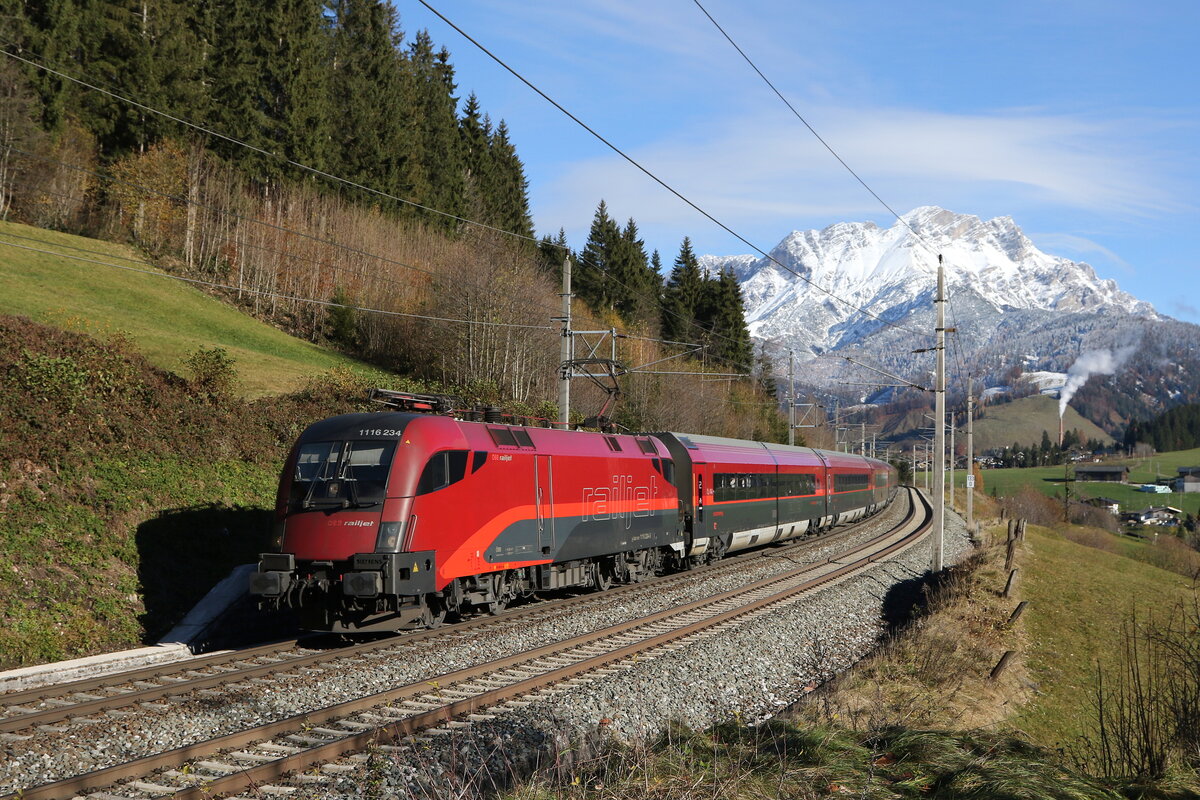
top-left (974, 449), bottom-right (1200, 515)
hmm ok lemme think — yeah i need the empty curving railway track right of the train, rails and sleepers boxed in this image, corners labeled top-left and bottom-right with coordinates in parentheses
top-left (5, 492), bottom-right (929, 800)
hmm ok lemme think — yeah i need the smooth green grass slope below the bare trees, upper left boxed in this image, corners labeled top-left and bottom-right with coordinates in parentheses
top-left (0, 222), bottom-right (379, 397)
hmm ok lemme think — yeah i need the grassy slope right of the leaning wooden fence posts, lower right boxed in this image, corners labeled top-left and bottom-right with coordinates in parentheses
top-left (1010, 527), bottom-right (1192, 747)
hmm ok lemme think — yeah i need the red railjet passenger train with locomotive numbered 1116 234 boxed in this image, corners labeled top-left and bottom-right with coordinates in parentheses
top-left (251, 396), bottom-right (896, 633)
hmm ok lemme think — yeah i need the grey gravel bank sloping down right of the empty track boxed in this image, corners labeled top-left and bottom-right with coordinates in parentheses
top-left (293, 503), bottom-right (972, 800)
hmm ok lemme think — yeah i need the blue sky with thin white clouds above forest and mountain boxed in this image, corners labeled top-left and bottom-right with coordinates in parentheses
top-left (396, 0), bottom-right (1200, 323)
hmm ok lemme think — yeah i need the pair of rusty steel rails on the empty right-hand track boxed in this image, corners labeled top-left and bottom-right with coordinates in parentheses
top-left (7, 491), bottom-right (930, 800)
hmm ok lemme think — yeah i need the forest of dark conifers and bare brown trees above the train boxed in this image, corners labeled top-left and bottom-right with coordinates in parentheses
top-left (0, 0), bottom-right (786, 439)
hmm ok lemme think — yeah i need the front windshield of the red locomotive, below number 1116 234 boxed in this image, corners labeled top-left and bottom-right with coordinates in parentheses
top-left (288, 441), bottom-right (396, 511)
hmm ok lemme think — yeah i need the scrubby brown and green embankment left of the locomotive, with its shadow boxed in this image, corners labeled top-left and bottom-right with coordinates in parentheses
top-left (0, 312), bottom-right (398, 669)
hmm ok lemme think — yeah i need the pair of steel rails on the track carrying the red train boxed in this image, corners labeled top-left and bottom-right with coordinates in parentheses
top-left (0, 501), bottom-right (902, 733)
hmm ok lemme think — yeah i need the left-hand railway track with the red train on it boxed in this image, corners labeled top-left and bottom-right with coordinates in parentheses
top-left (0, 501), bottom-right (902, 739)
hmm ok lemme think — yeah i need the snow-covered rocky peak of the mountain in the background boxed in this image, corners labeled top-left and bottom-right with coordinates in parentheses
top-left (700, 206), bottom-right (1158, 354)
